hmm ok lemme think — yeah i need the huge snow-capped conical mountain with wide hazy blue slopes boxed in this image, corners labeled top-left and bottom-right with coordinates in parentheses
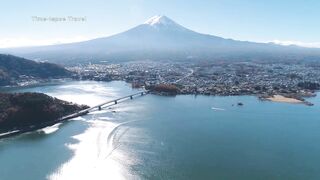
top-left (0, 16), bottom-right (320, 64)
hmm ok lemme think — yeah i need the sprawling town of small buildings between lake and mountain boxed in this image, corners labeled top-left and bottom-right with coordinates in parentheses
top-left (68, 61), bottom-right (320, 103)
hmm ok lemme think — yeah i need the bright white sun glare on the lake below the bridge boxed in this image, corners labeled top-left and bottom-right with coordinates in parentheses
top-left (50, 120), bottom-right (124, 180)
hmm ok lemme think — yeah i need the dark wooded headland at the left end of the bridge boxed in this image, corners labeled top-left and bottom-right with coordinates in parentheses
top-left (0, 93), bottom-right (89, 137)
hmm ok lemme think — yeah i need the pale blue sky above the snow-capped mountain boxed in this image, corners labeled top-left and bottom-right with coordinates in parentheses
top-left (0, 0), bottom-right (320, 47)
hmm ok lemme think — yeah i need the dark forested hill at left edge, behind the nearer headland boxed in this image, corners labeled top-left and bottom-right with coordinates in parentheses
top-left (0, 54), bottom-right (71, 86)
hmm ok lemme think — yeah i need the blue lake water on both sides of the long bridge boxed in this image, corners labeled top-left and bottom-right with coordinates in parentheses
top-left (0, 81), bottom-right (320, 180)
